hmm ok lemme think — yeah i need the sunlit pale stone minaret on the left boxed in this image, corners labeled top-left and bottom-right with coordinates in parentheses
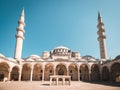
top-left (14, 8), bottom-right (25, 59)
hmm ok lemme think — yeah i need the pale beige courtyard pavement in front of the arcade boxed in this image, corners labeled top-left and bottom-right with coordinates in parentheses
top-left (0, 81), bottom-right (120, 90)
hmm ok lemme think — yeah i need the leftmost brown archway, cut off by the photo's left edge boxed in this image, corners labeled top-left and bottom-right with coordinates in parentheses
top-left (0, 62), bottom-right (10, 81)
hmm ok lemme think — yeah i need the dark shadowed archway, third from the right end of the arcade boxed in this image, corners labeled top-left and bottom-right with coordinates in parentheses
top-left (91, 64), bottom-right (100, 81)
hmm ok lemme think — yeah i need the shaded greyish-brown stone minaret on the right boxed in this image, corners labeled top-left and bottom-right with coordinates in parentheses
top-left (97, 12), bottom-right (107, 60)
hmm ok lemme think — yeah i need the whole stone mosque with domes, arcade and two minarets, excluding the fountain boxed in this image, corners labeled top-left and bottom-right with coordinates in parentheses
top-left (0, 9), bottom-right (120, 82)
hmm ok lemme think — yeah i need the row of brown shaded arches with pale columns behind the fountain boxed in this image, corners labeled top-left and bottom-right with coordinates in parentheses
top-left (0, 63), bottom-right (120, 82)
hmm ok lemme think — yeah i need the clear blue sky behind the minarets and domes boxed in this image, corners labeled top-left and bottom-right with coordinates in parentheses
top-left (0, 0), bottom-right (120, 59)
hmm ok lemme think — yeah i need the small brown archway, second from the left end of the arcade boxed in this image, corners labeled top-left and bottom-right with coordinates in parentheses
top-left (11, 66), bottom-right (19, 81)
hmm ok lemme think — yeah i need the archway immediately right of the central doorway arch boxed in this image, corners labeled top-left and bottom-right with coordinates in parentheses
top-left (68, 63), bottom-right (78, 81)
